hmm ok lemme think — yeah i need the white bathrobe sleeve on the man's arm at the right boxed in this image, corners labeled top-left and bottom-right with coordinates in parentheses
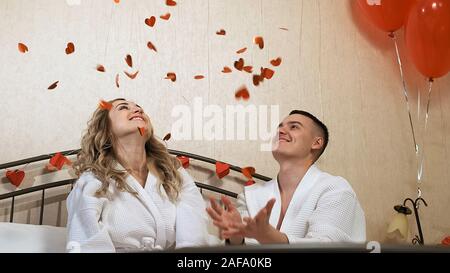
top-left (286, 190), bottom-right (365, 244)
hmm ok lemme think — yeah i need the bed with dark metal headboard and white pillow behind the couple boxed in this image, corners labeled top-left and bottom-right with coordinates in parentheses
top-left (0, 150), bottom-right (270, 253)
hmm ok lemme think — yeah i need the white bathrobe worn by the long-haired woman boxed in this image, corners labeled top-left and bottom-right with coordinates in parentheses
top-left (67, 164), bottom-right (208, 252)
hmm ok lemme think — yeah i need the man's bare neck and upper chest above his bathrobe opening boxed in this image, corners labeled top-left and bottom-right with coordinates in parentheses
top-left (278, 159), bottom-right (313, 193)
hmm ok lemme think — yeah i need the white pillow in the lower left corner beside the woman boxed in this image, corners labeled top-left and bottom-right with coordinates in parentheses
top-left (0, 223), bottom-right (67, 253)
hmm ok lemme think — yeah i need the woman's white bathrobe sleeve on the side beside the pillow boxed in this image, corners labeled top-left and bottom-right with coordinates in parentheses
top-left (67, 174), bottom-right (115, 252)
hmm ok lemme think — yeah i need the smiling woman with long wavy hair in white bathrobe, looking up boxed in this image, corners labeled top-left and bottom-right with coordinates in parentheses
top-left (67, 99), bottom-right (208, 252)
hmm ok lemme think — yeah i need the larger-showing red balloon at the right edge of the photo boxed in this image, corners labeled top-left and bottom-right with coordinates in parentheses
top-left (405, 0), bottom-right (450, 78)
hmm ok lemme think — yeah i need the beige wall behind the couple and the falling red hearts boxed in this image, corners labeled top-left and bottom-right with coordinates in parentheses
top-left (0, 0), bottom-right (450, 243)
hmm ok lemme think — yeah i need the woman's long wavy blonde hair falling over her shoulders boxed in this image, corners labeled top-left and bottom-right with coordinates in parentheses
top-left (73, 98), bottom-right (182, 202)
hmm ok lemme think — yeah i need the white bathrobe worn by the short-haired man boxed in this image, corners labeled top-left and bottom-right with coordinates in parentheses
top-left (237, 165), bottom-right (366, 244)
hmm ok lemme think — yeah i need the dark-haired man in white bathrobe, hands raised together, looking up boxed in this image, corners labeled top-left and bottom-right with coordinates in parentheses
top-left (207, 110), bottom-right (366, 244)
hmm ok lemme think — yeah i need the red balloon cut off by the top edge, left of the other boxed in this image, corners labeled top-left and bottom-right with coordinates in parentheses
top-left (357, 0), bottom-right (416, 32)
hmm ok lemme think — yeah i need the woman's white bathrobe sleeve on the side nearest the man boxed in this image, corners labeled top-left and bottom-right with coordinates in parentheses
top-left (175, 168), bottom-right (209, 248)
